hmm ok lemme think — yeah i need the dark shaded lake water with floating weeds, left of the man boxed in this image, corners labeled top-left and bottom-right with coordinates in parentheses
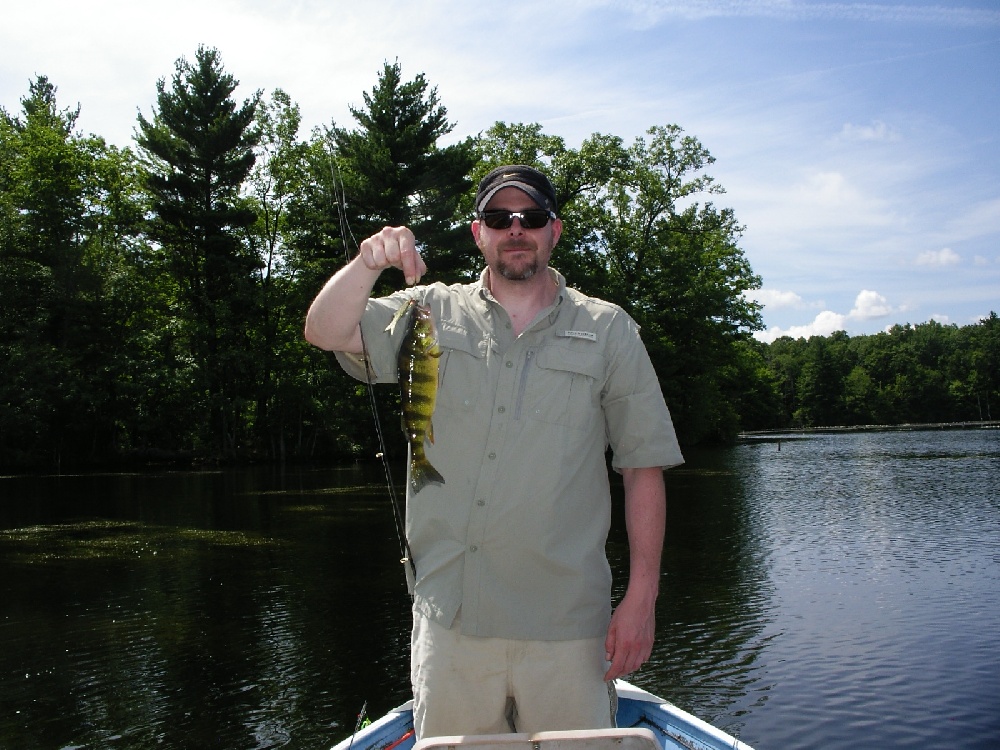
top-left (0, 471), bottom-right (408, 748)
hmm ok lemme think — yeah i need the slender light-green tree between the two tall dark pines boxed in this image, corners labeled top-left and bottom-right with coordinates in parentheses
top-left (240, 89), bottom-right (354, 460)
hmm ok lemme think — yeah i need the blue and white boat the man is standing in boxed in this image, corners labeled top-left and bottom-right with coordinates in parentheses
top-left (331, 680), bottom-right (753, 750)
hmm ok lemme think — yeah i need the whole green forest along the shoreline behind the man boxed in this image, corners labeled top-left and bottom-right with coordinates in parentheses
top-left (0, 47), bottom-right (1000, 470)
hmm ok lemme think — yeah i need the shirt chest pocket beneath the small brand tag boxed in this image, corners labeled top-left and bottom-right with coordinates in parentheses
top-left (517, 347), bottom-right (604, 429)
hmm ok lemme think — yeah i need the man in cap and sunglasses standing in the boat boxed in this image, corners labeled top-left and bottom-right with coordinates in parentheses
top-left (306, 165), bottom-right (683, 737)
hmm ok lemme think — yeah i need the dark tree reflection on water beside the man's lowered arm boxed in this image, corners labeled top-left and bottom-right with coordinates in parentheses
top-left (621, 450), bottom-right (773, 736)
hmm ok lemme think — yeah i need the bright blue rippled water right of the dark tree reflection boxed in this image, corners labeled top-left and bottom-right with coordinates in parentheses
top-left (738, 431), bottom-right (1000, 748)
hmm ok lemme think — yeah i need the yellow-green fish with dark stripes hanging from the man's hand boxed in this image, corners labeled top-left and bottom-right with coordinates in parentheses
top-left (386, 299), bottom-right (444, 492)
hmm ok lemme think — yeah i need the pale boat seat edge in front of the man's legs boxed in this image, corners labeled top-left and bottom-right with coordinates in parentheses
top-left (413, 728), bottom-right (661, 750)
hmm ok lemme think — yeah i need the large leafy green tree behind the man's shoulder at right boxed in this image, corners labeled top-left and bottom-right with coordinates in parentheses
top-left (602, 125), bottom-right (762, 442)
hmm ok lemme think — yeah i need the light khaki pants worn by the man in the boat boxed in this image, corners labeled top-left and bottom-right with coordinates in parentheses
top-left (410, 612), bottom-right (617, 739)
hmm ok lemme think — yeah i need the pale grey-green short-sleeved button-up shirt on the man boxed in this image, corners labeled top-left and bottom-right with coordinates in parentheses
top-left (337, 269), bottom-right (683, 640)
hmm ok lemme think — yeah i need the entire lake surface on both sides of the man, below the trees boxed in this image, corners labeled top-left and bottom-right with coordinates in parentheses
top-left (0, 430), bottom-right (1000, 750)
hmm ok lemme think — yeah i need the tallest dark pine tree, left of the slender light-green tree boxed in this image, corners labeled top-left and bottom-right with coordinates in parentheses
top-left (137, 47), bottom-right (261, 457)
